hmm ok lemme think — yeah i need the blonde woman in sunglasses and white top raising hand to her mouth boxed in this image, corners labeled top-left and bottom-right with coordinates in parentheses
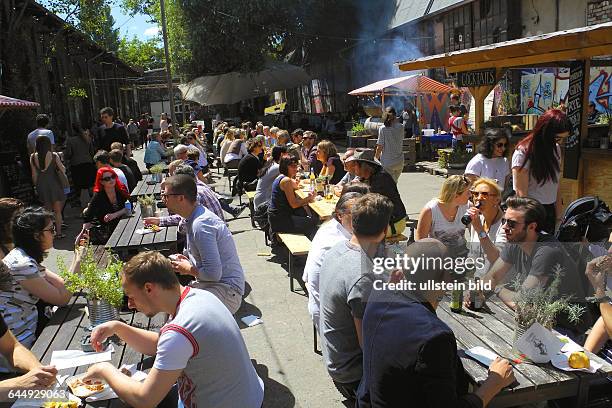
top-left (468, 177), bottom-right (506, 277)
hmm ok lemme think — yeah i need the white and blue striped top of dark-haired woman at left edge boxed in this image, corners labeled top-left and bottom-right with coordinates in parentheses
top-left (0, 248), bottom-right (45, 348)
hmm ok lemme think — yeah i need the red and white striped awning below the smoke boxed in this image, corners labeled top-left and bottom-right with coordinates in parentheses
top-left (349, 75), bottom-right (452, 95)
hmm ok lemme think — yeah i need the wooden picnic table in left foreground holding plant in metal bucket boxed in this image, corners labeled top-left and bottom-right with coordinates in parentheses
top-left (32, 246), bottom-right (165, 408)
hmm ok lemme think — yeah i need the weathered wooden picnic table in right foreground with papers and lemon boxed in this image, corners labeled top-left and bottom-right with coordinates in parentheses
top-left (437, 296), bottom-right (612, 408)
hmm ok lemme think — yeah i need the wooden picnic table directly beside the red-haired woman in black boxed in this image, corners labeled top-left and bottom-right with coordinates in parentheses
top-left (106, 200), bottom-right (178, 260)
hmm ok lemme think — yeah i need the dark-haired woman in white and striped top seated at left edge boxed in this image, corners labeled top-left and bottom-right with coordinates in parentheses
top-left (0, 207), bottom-right (83, 350)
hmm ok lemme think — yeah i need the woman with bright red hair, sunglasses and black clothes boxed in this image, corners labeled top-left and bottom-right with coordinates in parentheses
top-left (76, 167), bottom-right (130, 242)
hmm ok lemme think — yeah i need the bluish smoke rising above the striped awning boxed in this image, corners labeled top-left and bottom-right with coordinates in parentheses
top-left (352, 0), bottom-right (422, 87)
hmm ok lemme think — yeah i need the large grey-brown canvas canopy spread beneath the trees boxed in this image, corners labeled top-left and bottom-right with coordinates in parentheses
top-left (179, 61), bottom-right (310, 105)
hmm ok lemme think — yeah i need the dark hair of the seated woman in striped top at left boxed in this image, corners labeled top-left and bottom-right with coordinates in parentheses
top-left (12, 207), bottom-right (55, 263)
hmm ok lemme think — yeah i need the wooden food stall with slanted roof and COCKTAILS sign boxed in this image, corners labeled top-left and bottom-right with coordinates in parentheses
top-left (398, 23), bottom-right (612, 209)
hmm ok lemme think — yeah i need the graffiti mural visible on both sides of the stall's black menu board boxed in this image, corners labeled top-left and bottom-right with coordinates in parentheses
top-left (521, 67), bottom-right (612, 114)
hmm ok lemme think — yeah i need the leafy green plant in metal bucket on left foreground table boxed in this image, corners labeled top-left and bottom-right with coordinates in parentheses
top-left (57, 246), bottom-right (123, 327)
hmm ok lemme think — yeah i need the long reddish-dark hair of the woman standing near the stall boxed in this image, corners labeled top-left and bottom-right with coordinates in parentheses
top-left (517, 109), bottom-right (572, 184)
